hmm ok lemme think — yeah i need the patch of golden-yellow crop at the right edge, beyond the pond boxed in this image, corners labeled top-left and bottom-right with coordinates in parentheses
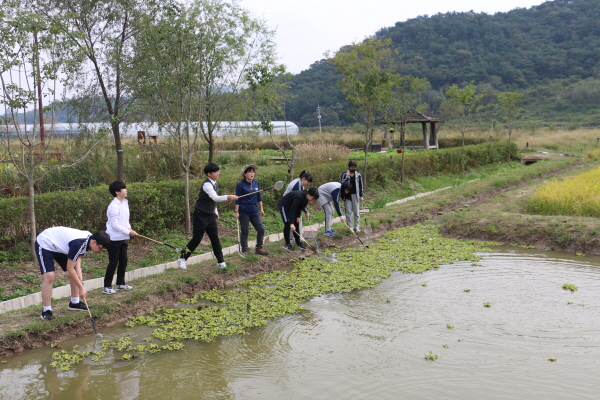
top-left (527, 167), bottom-right (600, 217)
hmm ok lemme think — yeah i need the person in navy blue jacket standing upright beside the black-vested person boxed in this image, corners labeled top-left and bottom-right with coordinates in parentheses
top-left (235, 164), bottom-right (269, 256)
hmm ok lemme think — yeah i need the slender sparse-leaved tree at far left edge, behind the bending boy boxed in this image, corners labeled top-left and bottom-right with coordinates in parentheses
top-left (0, 2), bottom-right (99, 259)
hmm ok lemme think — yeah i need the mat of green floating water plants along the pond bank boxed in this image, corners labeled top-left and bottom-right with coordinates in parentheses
top-left (53, 225), bottom-right (495, 368)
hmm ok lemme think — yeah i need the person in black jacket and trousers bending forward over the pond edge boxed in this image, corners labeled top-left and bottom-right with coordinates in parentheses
top-left (279, 188), bottom-right (319, 251)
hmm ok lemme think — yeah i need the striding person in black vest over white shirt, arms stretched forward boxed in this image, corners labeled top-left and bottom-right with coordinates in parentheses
top-left (177, 163), bottom-right (237, 269)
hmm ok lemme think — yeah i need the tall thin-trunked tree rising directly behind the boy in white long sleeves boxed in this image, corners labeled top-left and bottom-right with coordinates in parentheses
top-left (35, 0), bottom-right (169, 181)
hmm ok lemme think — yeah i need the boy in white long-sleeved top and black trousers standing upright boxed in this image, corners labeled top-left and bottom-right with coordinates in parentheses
top-left (102, 181), bottom-right (137, 294)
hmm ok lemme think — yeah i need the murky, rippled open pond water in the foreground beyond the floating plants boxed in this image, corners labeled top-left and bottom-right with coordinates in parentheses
top-left (0, 247), bottom-right (600, 400)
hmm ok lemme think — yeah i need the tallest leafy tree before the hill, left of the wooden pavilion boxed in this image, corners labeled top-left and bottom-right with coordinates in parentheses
top-left (332, 38), bottom-right (399, 184)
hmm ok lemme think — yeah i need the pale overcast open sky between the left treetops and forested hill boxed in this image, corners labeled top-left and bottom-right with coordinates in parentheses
top-left (239, 0), bottom-right (545, 74)
